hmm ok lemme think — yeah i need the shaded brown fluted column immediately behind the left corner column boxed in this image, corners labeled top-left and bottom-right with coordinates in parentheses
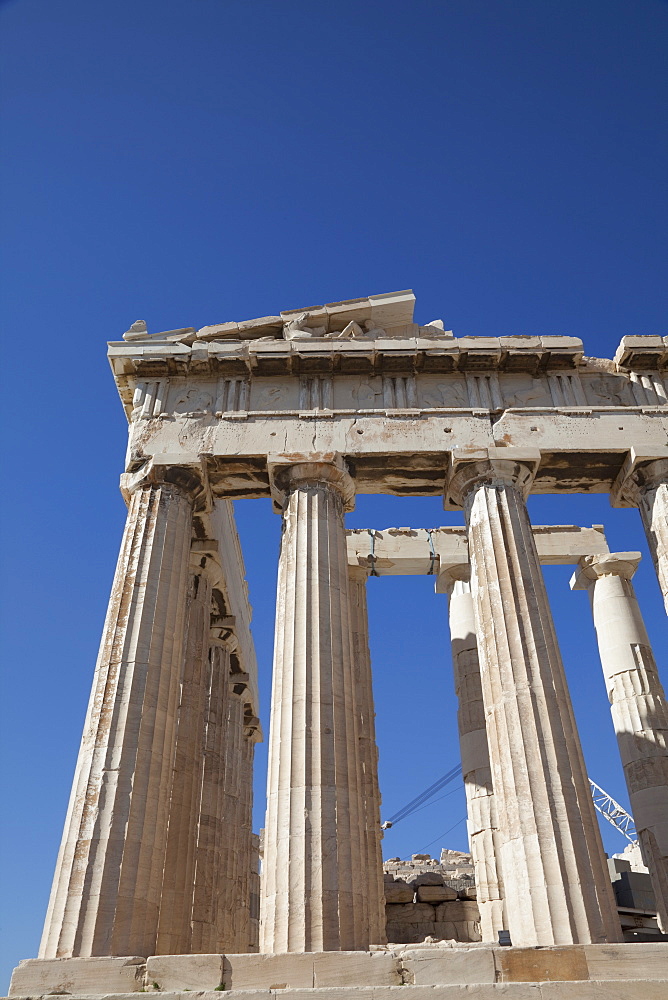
top-left (156, 554), bottom-right (211, 955)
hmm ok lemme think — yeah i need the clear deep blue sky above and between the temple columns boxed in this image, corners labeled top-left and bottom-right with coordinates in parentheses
top-left (0, 0), bottom-right (668, 989)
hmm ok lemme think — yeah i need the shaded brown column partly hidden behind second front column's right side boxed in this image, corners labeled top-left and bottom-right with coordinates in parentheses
top-left (348, 566), bottom-right (387, 944)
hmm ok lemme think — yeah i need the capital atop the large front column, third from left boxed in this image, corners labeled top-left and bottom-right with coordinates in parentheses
top-left (443, 448), bottom-right (540, 510)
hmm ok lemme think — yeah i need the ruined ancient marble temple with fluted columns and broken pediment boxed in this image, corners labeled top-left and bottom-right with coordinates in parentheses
top-left (6, 292), bottom-right (668, 1000)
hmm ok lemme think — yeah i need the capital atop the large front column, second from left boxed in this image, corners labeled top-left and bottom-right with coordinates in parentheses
top-left (267, 452), bottom-right (355, 512)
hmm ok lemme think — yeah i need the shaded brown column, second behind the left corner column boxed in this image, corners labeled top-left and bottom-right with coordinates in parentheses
top-left (191, 627), bottom-right (235, 955)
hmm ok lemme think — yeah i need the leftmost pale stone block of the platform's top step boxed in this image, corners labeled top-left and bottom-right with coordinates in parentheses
top-left (8, 956), bottom-right (146, 997)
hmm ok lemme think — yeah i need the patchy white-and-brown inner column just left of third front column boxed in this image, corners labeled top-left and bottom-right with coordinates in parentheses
top-left (439, 566), bottom-right (507, 943)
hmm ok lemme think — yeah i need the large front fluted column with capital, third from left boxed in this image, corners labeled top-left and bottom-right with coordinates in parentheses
top-left (449, 457), bottom-right (620, 946)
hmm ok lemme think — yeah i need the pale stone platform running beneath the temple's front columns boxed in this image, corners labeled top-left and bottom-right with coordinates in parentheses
top-left (9, 943), bottom-right (668, 1000)
